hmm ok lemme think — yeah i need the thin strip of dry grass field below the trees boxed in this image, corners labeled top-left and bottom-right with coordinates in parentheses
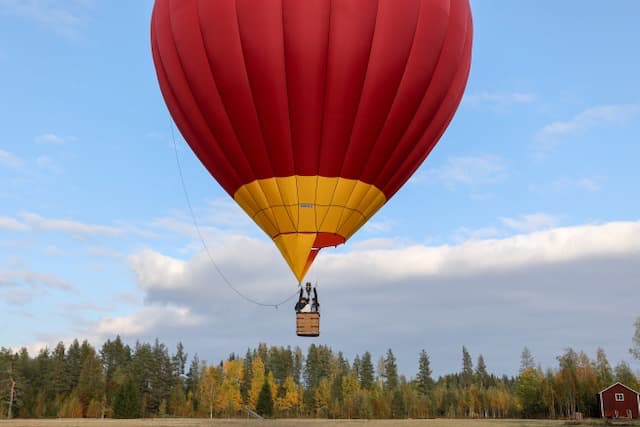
top-left (0, 418), bottom-right (620, 427)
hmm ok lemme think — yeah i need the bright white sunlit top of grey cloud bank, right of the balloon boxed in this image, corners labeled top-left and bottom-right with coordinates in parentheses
top-left (338, 221), bottom-right (640, 280)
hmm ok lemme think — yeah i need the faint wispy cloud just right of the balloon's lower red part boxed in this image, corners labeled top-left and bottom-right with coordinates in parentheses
top-left (418, 154), bottom-right (507, 187)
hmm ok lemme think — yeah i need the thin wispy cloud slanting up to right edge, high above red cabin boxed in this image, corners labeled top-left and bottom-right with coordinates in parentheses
top-left (534, 104), bottom-right (640, 150)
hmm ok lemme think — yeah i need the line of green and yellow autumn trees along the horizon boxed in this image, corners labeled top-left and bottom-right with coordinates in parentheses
top-left (0, 338), bottom-right (640, 418)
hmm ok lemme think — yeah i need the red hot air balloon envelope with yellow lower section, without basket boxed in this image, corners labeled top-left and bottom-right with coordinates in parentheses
top-left (151, 0), bottom-right (472, 281)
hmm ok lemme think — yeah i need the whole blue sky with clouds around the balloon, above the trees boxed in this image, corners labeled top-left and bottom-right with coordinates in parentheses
top-left (0, 0), bottom-right (640, 376)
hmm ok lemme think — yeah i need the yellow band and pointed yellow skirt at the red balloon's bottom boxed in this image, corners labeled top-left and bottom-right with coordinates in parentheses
top-left (234, 175), bottom-right (387, 280)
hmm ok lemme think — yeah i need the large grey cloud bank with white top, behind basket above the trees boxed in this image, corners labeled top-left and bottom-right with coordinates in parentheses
top-left (88, 219), bottom-right (640, 372)
